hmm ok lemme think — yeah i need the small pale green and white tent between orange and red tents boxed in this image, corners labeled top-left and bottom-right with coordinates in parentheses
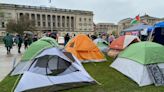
top-left (93, 38), bottom-right (109, 52)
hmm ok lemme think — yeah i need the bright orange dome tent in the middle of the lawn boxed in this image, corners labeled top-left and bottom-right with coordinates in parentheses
top-left (65, 34), bottom-right (105, 62)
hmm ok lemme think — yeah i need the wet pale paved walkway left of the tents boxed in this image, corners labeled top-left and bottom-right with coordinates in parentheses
top-left (0, 44), bottom-right (24, 81)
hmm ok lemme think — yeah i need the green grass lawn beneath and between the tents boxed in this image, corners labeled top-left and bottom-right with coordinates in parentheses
top-left (0, 57), bottom-right (164, 92)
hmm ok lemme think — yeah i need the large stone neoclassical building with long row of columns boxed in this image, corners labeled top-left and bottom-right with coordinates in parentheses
top-left (0, 4), bottom-right (94, 35)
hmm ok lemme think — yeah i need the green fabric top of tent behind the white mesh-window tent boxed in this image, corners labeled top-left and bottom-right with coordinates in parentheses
top-left (21, 37), bottom-right (59, 61)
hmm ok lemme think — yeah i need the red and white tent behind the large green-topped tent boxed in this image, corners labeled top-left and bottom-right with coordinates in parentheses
top-left (108, 35), bottom-right (140, 57)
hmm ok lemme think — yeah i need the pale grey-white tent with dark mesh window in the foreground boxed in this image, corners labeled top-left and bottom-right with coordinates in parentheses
top-left (11, 47), bottom-right (96, 92)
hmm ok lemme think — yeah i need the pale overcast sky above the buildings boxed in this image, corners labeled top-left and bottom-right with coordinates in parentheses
top-left (0, 0), bottom-right (164, 23)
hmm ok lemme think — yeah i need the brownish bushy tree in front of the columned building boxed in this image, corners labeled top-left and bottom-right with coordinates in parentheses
top-left (6, 16), bottom-right (36, 35)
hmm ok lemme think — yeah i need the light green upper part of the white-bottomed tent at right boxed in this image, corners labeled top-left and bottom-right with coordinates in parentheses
top-left (119, 42), bottom-right (164, 64)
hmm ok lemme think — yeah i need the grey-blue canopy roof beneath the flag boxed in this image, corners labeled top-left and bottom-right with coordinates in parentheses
top-left (123, 23), bottom-right (152, 32)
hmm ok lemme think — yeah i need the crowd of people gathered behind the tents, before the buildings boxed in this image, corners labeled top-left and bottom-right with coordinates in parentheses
top-left (3, 33), bottom-right (115, 54)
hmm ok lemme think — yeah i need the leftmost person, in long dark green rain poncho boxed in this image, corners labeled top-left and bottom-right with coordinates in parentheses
top-left (3, 33), bottom-right (13, 54)
